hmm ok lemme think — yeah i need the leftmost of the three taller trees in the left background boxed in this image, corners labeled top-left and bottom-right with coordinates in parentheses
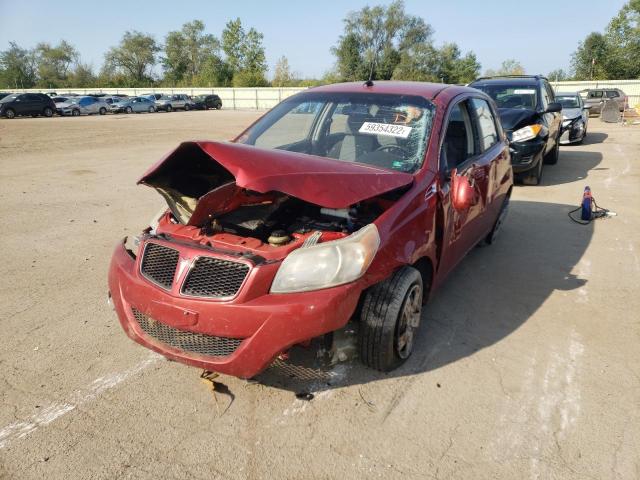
top-left (104, 31), bottom-right (160, 85)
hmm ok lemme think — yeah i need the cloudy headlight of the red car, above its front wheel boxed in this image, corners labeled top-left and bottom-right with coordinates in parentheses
top-left (271, 224), bottom-right (380, 293)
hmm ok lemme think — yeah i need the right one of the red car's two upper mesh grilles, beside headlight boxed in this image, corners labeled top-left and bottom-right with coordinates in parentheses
top-left (182, 257), bottom-right (249, 298)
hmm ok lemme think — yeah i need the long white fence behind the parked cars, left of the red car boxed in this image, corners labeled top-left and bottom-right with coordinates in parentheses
top-left (5, 87), bottom-right (306, 110)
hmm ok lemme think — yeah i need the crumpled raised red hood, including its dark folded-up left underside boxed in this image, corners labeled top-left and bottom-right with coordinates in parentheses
top-left (138, 142), bottom-right (413, 223)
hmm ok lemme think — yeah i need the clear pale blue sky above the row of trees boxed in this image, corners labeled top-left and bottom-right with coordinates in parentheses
top-left (0, 0), bottom-right (625, 77)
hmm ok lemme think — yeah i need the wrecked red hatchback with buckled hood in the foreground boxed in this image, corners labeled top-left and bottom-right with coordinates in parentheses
top-left (109, 82), bottom-right (513, 378)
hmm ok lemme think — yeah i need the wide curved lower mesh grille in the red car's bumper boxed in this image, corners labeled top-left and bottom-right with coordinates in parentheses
top-left (131, 308), bottom-right (242, 357)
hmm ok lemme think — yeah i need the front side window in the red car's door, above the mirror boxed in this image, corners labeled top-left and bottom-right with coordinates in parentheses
top-left (440, 101), bottom-right (477, 171)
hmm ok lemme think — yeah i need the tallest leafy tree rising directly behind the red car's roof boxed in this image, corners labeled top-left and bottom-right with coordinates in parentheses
top-left (331, 0), bottom-right (433, 81)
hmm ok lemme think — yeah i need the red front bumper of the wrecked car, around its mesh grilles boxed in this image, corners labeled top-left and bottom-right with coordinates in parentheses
top-left (109, 240), bottom-right (362, 378)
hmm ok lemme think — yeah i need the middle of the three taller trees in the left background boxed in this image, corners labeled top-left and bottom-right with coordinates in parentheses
top-left (162, 20), bottom-right (221, 84)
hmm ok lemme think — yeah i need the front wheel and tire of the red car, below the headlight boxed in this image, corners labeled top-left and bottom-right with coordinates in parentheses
top-left (358, 266), bottom-right (423, 372)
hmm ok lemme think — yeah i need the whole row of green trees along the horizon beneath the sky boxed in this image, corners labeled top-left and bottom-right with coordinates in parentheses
top-left (0, 0), bottom-right (640, 88)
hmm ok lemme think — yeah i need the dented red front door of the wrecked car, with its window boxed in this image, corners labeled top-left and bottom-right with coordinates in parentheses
top-left (438, 96), bottom-right (492, 275)
